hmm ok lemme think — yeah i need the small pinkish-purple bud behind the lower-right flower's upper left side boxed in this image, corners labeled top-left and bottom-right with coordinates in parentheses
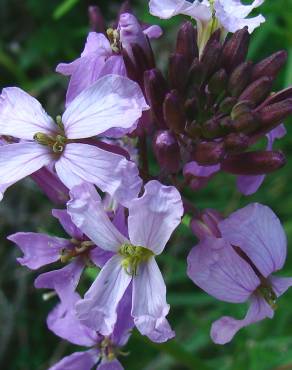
top-left (190, 209), bottom-right (223, 240)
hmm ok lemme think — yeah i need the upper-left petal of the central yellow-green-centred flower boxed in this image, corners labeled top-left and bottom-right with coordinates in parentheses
top-left (68, 183), bottom-right (128, 252)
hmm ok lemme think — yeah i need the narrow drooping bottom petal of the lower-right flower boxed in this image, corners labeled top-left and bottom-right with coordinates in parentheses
top-left (211, 296), bottom-right (274, 344)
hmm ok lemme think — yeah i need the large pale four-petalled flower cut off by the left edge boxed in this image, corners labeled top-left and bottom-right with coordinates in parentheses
top-left (0, 75), bottom-right (148, 203)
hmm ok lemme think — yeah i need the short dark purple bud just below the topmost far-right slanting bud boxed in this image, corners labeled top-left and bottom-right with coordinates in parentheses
top-left (238, 77), bottom-right (273, 107)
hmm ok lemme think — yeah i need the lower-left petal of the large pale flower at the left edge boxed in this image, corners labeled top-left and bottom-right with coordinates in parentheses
top-left (0, 142), bottom-right (51, 185)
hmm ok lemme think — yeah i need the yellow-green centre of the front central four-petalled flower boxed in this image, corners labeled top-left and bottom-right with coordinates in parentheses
top-left (119, 244), bottom-right (154, 276)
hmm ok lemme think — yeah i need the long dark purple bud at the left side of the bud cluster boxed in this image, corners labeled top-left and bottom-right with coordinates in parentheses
top-left (144, 69), bottom-right (168, 129)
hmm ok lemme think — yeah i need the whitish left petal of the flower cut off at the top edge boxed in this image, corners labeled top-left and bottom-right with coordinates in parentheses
top-left (149, 0), bottom-right (212, 22)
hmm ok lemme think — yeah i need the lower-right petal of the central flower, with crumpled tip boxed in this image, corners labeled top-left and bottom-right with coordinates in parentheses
top-left (132, 258), bottom-right (175, 343)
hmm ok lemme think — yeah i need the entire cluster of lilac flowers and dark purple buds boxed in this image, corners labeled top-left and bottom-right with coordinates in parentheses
top-left (0, 0), bottom-right (292, 370)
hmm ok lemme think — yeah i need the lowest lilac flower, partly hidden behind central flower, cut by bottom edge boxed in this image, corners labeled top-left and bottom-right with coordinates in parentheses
top-left (47, 289), bottom-right (134, 370)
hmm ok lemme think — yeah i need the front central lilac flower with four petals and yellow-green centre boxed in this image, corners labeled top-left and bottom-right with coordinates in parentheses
top-left (68, 181), bottom-right (183, 342)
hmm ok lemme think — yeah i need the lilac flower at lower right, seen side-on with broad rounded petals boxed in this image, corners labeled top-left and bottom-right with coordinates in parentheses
top-left (188, 203), bottom-right (292, 344)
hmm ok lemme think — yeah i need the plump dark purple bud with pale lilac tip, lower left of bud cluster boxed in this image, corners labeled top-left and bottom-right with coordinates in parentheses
top-left (153, 130), bottom-right (180, 173)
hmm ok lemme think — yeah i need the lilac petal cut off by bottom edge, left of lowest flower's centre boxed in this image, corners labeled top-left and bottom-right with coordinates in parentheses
top-left (49, 349), bottom-right (99, 370)
